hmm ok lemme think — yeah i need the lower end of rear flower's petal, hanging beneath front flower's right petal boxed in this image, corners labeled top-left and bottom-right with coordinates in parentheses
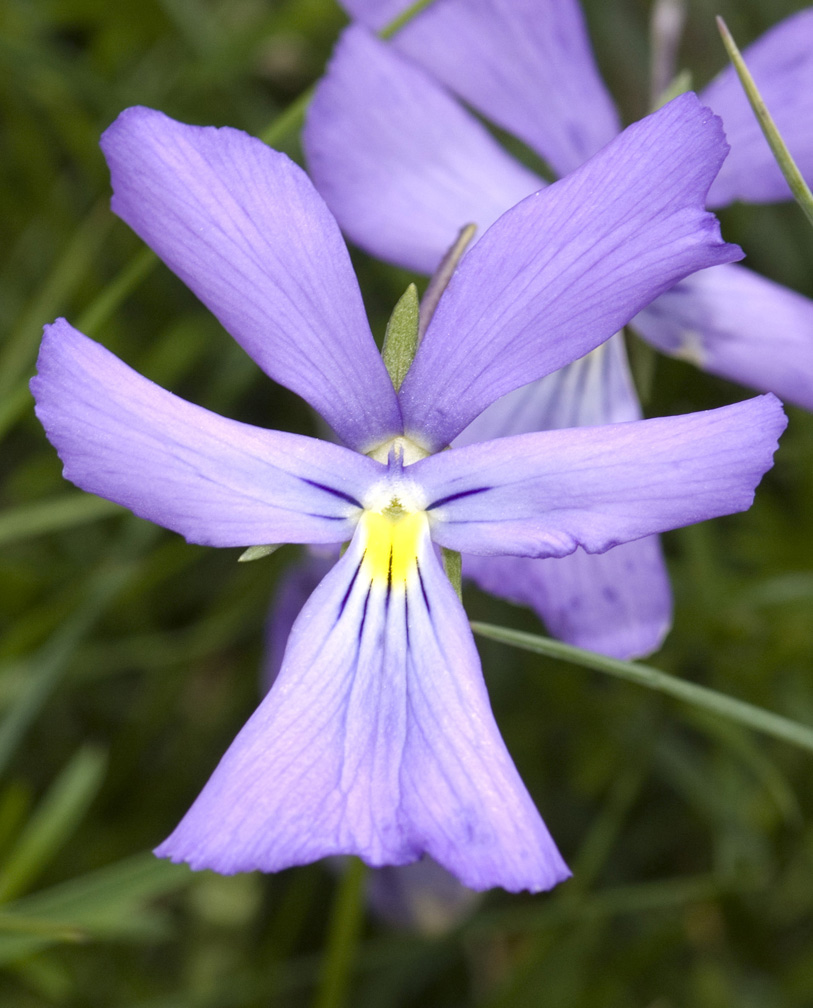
top-left (463, 535), bottom-right (672, 660)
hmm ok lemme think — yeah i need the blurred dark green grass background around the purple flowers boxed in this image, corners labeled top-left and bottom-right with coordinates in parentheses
top-left (0, 0), bottom-right (813, 1008)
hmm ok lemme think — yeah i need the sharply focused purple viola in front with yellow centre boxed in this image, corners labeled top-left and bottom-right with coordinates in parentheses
top-left (32, 102), bottom-right (785, 891)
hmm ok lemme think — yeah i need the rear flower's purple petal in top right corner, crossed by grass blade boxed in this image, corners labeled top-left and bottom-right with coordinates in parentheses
top-left (701, 9), bottom-right (813, 207)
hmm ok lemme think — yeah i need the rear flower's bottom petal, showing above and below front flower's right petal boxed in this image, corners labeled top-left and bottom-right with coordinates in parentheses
top-left (454, 334), bottom-right (672, 659)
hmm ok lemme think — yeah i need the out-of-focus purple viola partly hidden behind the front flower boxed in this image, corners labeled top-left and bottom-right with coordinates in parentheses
top-left (303, 0), bottom-right (813, 658)
